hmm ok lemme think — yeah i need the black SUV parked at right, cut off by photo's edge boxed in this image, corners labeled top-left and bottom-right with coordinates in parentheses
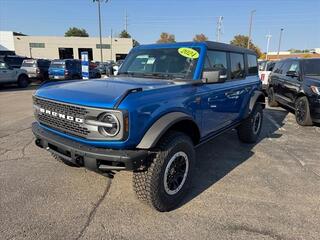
top-left (268, 58), bottom-right (320, 126)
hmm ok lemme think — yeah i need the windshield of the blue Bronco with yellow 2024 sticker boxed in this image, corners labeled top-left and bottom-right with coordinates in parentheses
top-left (119, 47), bottom-right (200, 79)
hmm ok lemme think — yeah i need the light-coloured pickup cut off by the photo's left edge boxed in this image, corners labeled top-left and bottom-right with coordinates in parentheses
top-left (0, 61), bottom-right (30, 88)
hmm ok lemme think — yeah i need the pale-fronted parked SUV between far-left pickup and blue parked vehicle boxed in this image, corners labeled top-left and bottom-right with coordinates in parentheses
top-left (21, 59), bottom-right (51, 81)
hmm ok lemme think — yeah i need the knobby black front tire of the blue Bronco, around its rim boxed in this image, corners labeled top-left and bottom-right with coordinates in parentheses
top-left (133, 131), bottom-right (195, 212)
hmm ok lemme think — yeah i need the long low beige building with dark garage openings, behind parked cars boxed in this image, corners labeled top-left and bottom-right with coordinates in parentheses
top-left (0, 31), bottom-right (133, 61)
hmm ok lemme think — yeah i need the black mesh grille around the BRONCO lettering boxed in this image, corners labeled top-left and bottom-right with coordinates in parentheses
top-left (33, 97), bottom-right (90, 138)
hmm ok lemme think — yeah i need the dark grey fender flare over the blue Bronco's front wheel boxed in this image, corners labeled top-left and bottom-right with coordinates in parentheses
top-left (137, 112), bottom-right (194, 149)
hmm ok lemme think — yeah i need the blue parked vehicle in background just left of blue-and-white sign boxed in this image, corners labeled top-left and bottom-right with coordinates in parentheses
top-left (49, 59), bottom-right (82, 80)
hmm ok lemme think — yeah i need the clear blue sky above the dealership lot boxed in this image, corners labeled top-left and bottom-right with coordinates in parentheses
top-left (0, 0), bottom-right (320, 51)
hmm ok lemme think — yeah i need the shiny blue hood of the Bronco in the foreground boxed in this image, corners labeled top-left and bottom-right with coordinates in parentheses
top-left (35, 77), bottom-right (182, 108)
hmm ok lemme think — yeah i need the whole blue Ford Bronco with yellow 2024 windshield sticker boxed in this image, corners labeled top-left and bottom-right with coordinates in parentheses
top-left (32, 42), bottom-right (265, 211)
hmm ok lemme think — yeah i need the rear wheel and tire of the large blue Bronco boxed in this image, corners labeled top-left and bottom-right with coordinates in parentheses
top-left (237, 103), bottom-right (263, 143)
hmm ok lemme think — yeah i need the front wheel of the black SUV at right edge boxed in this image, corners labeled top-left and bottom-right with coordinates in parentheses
top-left (295, 96), bottom-right (313, 126)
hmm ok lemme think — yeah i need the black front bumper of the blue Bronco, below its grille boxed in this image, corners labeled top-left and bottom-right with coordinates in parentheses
top-left (32, 122), bottom-right (149, 173)
